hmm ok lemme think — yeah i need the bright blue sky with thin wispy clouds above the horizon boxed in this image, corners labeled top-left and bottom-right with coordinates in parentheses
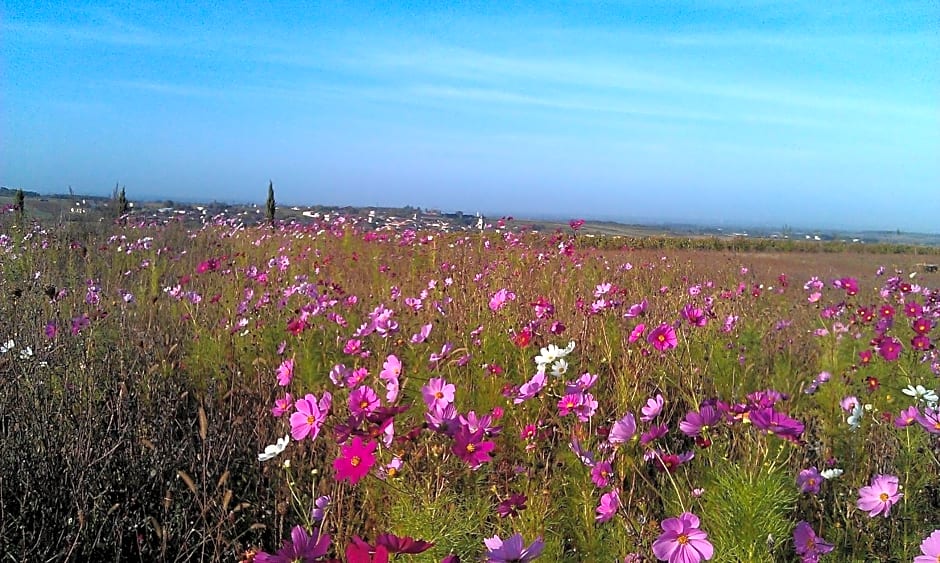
top-left (0, 0), bottom-right (940, 232)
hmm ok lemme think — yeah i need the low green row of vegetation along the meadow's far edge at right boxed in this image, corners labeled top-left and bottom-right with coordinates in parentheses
top-left (578, 236), bottom-right (940, 256)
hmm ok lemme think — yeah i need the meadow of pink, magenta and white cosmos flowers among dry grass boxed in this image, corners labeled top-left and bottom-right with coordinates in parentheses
top-left (0, 209), bottom-right (940, 563)
